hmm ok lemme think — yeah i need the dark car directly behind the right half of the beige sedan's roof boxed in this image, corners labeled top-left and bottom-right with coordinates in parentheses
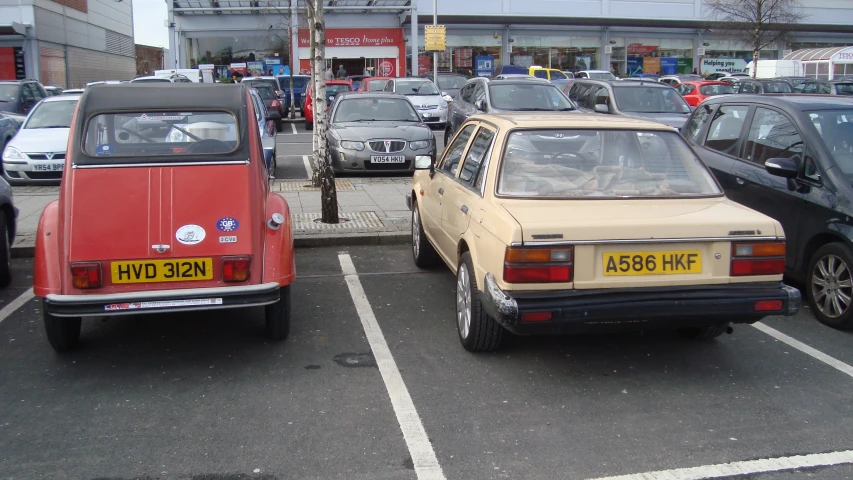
top-left (569, 79), bottom-right (690, 129)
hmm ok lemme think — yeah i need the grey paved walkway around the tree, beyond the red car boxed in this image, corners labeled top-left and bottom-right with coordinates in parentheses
top-left (12, 125), bottom-right (444, 258)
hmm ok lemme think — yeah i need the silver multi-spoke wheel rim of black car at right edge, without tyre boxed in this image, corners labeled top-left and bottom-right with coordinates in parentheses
top-left (812, 254), bottom-right (853, 318)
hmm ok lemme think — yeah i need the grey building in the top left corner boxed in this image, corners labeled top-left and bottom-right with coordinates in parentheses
top-left (0, 0), bottom-right (136, 88)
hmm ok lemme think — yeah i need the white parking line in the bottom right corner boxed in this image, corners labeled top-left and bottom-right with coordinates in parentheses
top-left (596, 450), bottom-right (853, 480)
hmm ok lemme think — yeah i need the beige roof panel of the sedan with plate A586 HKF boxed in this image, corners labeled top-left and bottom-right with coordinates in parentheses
top-left (471, 113), bottom-right (676, 132)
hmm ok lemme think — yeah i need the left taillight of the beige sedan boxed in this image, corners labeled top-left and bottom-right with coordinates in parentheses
top-left (504, 247), bottom-right (574, 283)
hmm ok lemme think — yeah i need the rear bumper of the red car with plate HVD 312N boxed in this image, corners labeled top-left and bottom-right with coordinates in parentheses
top-left (44, 282), bottom-right (280, 317)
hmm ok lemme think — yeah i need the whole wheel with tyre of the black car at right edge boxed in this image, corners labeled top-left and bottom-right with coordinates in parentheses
top-left (807, 243), bottom-right (853, 329)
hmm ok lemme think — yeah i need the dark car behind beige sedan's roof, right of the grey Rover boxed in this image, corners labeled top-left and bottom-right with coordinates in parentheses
top-left (444, 77), bottom-right (577, 141)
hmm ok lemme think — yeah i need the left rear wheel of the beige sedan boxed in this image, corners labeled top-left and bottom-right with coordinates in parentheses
top-left (456, 252), bottom-right (504, 352)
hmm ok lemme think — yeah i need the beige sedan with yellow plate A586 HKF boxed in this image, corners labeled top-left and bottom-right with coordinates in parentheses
top-left (407, 114), bottom-right (800, 351)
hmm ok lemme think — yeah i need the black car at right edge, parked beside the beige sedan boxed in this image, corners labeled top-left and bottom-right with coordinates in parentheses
top-left (682, 95), bottom-right (853, 328)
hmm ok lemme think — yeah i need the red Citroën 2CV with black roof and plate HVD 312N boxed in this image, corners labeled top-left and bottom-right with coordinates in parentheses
top-left (33, 83), bottom-right (296, 352)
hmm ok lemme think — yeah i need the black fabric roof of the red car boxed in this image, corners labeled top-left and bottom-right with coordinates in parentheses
top-left (80, 82), bottom-right (246, 118)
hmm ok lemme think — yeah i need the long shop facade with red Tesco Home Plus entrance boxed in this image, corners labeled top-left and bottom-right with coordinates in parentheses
top-left (167, 0), bottom-right (853, 79)
